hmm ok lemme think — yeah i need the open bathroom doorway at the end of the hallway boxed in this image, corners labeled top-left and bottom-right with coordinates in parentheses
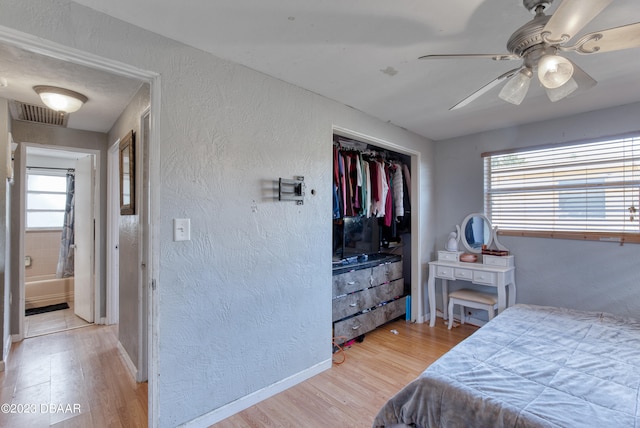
top-left (20, 143), bottom-right (100, 338)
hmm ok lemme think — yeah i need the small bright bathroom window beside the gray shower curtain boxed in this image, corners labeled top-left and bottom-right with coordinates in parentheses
top-left (26, 173), bottom-right (67, 229)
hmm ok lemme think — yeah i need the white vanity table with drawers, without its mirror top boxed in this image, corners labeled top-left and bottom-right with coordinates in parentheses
top-left (427, 260), bottom-right (516, 327)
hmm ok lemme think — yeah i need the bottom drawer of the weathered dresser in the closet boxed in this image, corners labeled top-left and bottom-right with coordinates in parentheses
top-left (333, 297), bottom-right (406, 343)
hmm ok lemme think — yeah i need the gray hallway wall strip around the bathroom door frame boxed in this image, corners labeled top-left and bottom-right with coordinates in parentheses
top-left (11, 120), bottom-right (107, 334)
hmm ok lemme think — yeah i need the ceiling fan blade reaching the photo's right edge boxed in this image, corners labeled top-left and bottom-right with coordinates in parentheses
top-left (575, 22), bottom-right (640, 54)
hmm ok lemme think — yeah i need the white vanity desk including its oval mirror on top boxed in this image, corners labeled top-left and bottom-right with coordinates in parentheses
top-left (427, 213), bottom-right (516, 327)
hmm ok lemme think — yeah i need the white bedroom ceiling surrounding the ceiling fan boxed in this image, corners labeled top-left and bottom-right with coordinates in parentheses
top-left (0, 0), bottom-right (640, 140)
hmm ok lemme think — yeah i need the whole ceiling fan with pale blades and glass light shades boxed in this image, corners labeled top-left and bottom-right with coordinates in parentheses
top-left (419, 0), bottom-right (640, 110)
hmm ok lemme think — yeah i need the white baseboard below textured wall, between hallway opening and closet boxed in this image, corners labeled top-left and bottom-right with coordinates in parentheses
top-left (180, 360), bottom-right (332, 428)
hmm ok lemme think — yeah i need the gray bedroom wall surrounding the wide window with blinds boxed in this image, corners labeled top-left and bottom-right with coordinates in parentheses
top-left (433, 103), bottom-right (640, 317)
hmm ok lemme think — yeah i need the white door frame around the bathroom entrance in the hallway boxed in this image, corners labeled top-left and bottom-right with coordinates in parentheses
top-left (14, 142), bottom-right (102, 341)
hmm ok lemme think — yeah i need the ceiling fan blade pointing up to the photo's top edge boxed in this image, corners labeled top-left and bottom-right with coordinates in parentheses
top-left (542, 0), bottom-right (613, 44)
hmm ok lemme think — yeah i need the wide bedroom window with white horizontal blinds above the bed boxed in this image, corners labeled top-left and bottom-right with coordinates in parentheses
top-left (483, 136), bottom-right (640, 242)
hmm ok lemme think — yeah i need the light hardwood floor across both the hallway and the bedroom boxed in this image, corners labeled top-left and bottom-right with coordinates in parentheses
top-left (0, 319), bottom-right (477, 428)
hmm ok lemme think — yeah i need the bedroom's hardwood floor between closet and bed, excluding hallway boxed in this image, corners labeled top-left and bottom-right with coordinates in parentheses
top-left (213, 318), bottom-right (477, 428)
